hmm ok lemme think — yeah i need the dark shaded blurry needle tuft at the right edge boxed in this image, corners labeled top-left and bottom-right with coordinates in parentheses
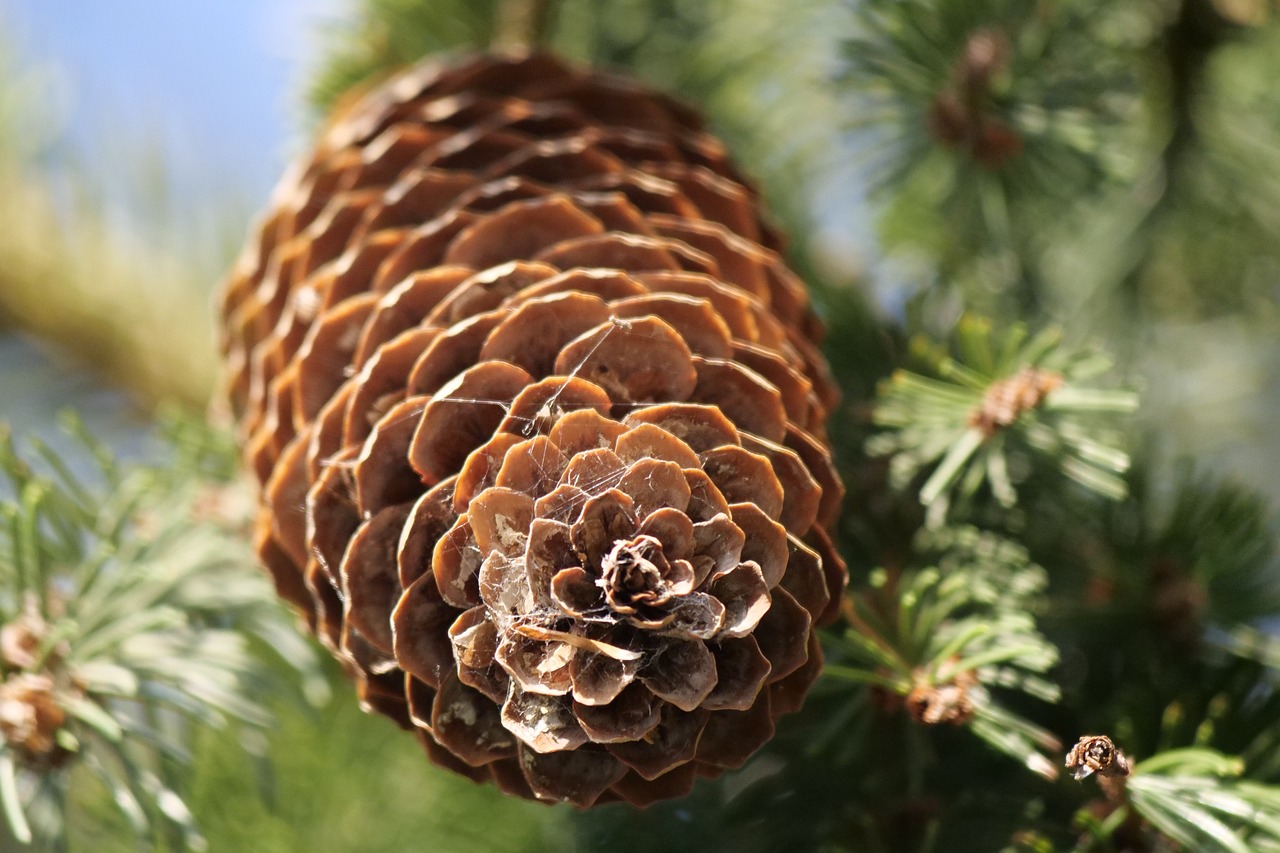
top-left (1064, 461), bottom-right (1280, 666)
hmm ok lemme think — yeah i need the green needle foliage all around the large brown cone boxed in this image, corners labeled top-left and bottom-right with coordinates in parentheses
top-left (0, 0), bottom-right (1280, 853)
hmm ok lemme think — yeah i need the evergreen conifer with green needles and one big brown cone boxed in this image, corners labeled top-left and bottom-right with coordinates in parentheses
top-left (0, 0), bottom-right (1280, 853)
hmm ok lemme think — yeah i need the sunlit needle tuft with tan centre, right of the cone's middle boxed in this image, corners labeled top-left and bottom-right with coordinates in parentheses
top-left (867, 316), bottom-right (1137, 525)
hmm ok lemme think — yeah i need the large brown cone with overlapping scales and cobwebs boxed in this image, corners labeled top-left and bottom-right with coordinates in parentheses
top-left (223, 56), bottom-right (845, 806)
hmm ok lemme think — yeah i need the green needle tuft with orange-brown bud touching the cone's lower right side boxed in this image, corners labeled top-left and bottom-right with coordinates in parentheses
top-left (824, 528), bottom-right (1060, 779)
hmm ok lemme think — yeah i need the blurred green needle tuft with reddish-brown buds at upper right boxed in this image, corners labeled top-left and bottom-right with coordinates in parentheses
top-left (841, 0), bottom-right (1139, 316)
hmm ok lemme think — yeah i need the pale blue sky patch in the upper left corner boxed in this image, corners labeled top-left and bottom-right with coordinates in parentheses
top-left (0, 0), bottom-right (344, 200)
